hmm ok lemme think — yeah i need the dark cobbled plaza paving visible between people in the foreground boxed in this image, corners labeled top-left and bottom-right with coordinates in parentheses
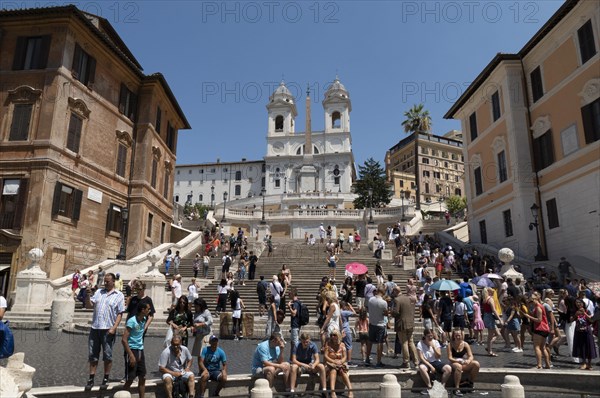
top-left (8, 330), bottom-right (597, 397)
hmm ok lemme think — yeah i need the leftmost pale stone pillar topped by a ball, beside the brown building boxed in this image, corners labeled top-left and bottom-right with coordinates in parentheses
top-left (12, 247), bottom-right (52, 312)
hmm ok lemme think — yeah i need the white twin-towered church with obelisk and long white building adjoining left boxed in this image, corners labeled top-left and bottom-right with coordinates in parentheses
top-left (173, 77), bottom-right (356, 214)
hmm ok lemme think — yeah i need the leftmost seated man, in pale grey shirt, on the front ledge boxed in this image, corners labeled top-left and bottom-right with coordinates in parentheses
top-left (158, 334), bottom-right (195, 397)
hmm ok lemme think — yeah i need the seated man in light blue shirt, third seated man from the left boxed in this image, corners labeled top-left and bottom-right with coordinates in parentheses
top-left (252, 333), bottom-right (290, 387)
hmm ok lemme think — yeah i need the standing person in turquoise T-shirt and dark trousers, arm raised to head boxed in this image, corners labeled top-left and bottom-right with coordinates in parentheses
top-left (121, 301), bottom-right (151, 398)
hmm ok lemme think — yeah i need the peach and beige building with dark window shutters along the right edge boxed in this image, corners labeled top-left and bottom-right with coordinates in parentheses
top-left (445, 0), bottom-right (600, 264)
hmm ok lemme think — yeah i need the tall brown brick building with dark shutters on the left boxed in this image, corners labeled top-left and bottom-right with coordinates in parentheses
top-left (0, 6), bottom-right (190, 294)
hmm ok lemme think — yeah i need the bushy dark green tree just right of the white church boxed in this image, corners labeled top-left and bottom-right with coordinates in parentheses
top-left (354, 158), bottom-right (393, 209)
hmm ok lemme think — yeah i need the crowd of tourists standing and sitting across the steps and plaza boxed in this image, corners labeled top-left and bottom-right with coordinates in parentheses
top-left (56, 225), bottom-right (600, 397)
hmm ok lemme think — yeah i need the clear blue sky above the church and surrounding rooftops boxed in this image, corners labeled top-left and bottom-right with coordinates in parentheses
top-left (54, 0), bottom-right (563, 164)
